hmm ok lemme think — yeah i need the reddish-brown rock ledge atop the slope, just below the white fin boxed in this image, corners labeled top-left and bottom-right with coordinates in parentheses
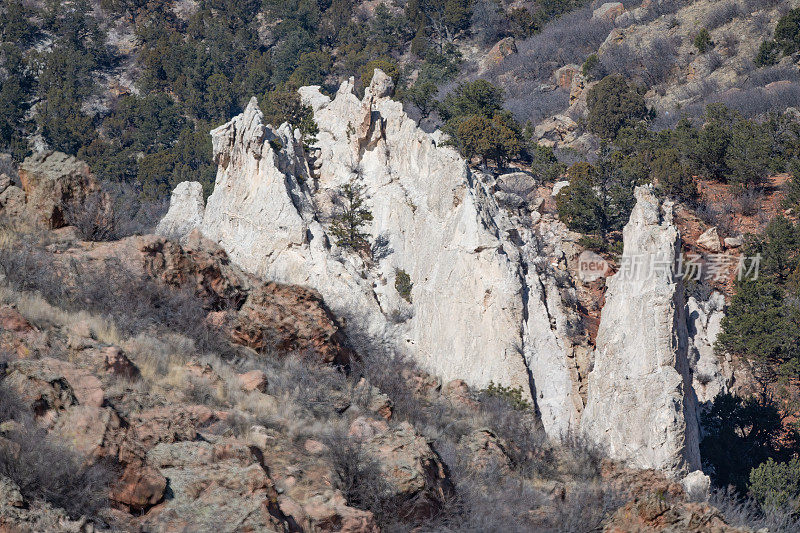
top-left (75, 231), bottom-right (353, 364)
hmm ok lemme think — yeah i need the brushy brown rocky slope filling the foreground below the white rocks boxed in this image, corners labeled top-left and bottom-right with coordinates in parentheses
top-left (0, 148), bottom-right (756, 531)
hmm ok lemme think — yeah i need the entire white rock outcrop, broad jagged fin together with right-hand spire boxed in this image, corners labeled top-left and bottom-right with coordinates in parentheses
top-left (159, 71), bottom-right (725, 475)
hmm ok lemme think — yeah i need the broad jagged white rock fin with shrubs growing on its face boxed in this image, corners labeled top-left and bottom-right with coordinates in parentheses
top-left (158, 70), bottom-right (583, 436)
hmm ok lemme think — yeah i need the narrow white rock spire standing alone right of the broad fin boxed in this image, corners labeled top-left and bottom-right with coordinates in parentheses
top-left (581, 187), bottom-right (700, 476)
